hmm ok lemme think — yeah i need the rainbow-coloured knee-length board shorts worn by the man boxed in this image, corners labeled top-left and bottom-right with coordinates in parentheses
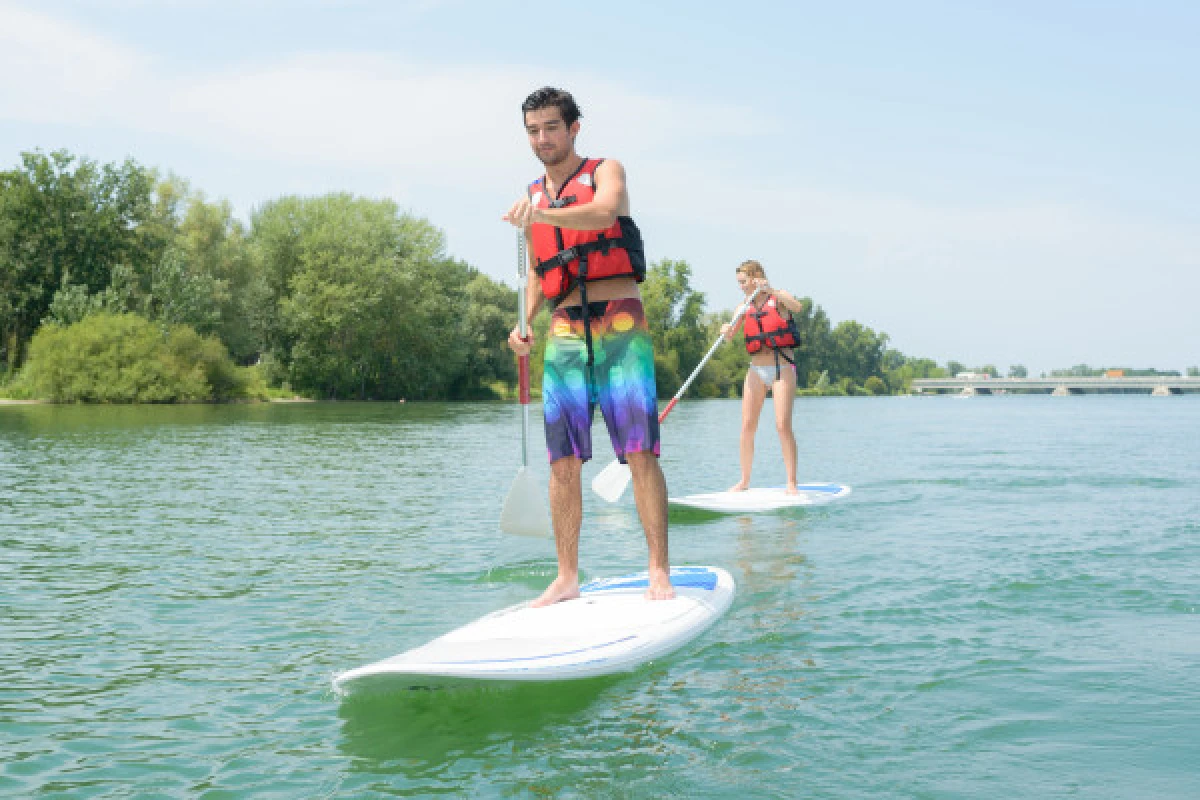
top-left (541, 297), bottom-right (659, 463)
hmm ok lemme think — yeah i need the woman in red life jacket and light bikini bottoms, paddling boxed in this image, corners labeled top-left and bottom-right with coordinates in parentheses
top-left (721, 261), bottom-right (804, 494)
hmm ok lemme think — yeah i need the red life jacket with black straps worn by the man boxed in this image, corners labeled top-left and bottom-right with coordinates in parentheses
top-left (529, 158), bottom-right (646, 301)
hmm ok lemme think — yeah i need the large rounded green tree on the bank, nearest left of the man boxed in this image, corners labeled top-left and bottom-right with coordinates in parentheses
top-left (251, 194), bottom-right (515, 399)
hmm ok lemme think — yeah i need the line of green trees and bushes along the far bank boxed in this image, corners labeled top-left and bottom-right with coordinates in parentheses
top-left (0, 151), bottom-right (947, 402)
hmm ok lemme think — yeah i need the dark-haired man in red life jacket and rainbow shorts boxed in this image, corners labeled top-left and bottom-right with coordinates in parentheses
top-left (504, 88), bottom-right (674, 606)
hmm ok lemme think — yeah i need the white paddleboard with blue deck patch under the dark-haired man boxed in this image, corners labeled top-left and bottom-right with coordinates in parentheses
top-left (334, 566), bottom-right (736, 693)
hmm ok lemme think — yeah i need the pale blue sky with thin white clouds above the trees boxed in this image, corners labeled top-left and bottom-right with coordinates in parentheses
top-left (0, 0), bottom-right (1200, 375)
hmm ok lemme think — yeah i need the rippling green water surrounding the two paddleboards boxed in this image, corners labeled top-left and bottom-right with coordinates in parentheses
top-left (0, 396), bottom-right (1200, 798)
